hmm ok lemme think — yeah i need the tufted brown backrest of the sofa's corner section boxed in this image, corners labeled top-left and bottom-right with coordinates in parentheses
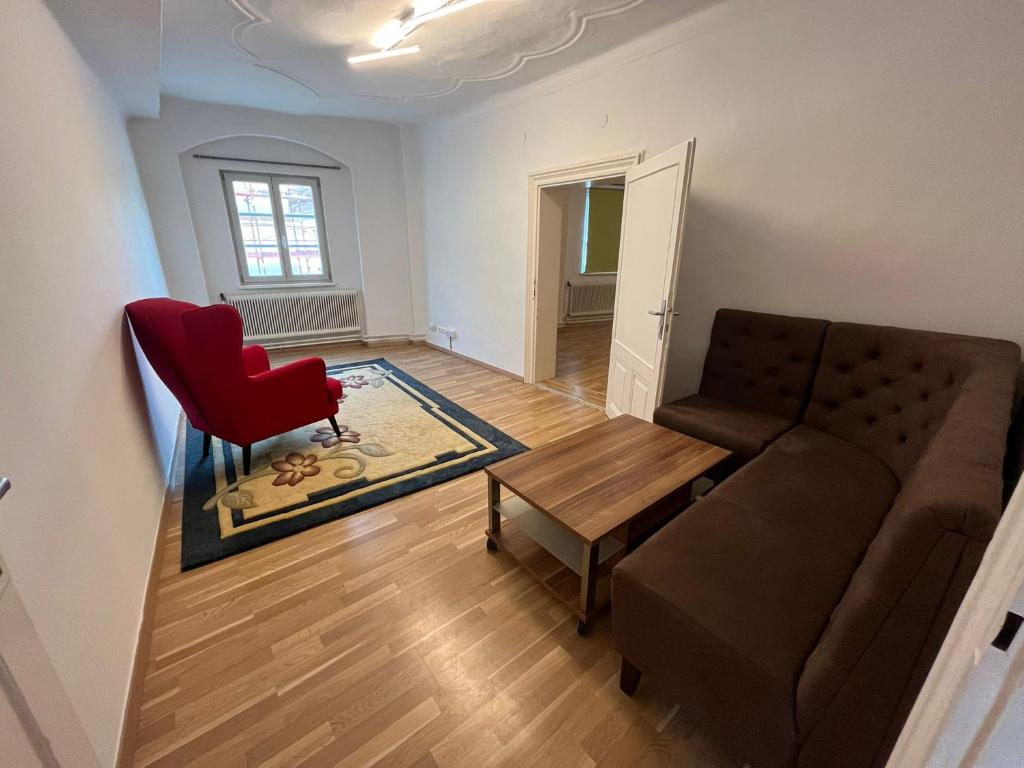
top-left (804, 323), bottom-right (1020, 481)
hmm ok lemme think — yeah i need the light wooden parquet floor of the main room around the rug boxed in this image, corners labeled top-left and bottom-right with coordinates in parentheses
top-left (129, 346), bottom-right (722, 768)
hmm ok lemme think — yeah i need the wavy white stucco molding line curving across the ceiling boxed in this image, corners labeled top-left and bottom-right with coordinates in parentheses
top-left (218, 0), bottom-right (647, 102)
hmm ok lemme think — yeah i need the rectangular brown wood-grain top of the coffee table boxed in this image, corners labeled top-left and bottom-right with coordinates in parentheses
top-left (484, 416), bottom-right (731, 543)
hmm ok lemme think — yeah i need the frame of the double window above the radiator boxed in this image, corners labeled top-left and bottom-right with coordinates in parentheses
top-left (220, 170), bottom-right (331, 286)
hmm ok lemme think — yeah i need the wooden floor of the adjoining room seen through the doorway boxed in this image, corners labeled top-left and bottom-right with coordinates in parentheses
top-left (542, 321), bottom-right (611, 408)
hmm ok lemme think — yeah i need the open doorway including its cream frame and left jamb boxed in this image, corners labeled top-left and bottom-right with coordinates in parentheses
top-left (524, 153), bottom-right (640, 408)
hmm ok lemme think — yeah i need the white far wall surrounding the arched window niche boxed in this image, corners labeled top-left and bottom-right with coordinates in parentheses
top-left (128, 98), bottom-right (414, 337)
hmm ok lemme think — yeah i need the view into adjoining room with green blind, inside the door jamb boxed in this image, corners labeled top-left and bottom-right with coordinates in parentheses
top-left (540, 176), bottom-right (626, 408)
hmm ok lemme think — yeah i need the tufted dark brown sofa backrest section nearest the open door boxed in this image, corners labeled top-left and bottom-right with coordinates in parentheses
top-left (700, 309), bottom-right (828, 421)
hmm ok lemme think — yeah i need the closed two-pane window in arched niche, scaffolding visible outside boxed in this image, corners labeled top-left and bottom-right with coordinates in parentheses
top-left (220, 171), bottom-right (331, 284)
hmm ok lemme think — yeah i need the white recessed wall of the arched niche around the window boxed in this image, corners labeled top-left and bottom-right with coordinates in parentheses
top-left (178, 136), bottom-right (362, 302)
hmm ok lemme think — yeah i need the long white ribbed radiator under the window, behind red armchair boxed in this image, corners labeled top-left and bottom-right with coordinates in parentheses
top-left (221, 291), bottom-right (362, 344)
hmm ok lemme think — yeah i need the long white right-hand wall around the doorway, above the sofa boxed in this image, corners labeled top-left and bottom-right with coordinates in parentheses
top-left (420, 0), bottom-right (1024, 393)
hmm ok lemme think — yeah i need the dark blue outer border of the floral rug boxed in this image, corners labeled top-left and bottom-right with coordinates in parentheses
top-left (181, 357), bottom-right (528, 571)
